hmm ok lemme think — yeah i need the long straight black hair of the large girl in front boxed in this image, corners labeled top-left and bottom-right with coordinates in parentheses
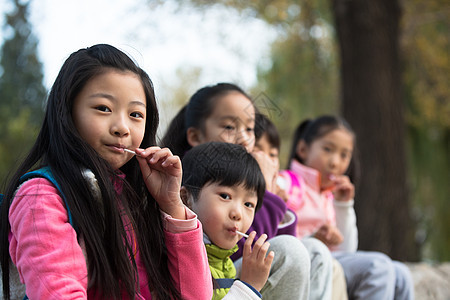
top-left (0, 44), bottom-right (180, 299)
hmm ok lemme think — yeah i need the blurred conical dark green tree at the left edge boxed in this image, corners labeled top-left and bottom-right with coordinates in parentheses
top-left (0, 0), bottom-right (46, 183)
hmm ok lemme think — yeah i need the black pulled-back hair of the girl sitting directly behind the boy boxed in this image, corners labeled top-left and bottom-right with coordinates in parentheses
top-left (161, 83), bottom-right (253, 157)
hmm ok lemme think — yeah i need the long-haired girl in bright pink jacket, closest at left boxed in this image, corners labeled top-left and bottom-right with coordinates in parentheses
top-left (0, 45), bottom-right (212, 299)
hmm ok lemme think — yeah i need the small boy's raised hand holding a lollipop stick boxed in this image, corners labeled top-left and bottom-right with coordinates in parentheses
top-left (241, 231), bottom-right (275, 291)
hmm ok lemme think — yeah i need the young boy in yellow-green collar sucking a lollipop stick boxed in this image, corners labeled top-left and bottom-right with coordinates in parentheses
top-left (181, 142), bottom-right (274, 300)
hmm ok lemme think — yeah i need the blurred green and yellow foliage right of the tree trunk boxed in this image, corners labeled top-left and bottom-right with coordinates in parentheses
top-left (401, 0), bottom-right (450, 261)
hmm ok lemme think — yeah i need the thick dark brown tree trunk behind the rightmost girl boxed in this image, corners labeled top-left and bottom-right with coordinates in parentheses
top-left (332, 0), bottom-right (418, 261)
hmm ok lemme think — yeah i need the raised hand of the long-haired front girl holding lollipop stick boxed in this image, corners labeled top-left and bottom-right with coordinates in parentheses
top-left (136, 146), bottom-right (186, 220)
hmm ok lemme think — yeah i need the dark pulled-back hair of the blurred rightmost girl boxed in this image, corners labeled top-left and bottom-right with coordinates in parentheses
top-left (287, 115), bottom-right (360, 184)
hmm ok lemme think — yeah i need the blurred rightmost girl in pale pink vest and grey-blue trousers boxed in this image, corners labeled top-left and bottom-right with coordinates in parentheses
top-left (281, 116), bottom-right (414, 300)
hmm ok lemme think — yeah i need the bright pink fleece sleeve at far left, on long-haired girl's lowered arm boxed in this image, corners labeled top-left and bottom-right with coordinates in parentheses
top-left (9, 178), bottom-right (87, 299)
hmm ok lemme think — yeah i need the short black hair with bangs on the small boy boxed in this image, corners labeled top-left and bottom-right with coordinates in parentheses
top-left (182, 142), bottom-right (266, 210)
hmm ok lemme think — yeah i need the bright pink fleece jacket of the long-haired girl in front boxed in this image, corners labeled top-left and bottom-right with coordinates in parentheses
top-left (9, 178), bottom-right (212, 299)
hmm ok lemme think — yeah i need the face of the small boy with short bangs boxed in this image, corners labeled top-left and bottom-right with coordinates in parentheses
top-left (191, 183), bottom-right (258, 249)
